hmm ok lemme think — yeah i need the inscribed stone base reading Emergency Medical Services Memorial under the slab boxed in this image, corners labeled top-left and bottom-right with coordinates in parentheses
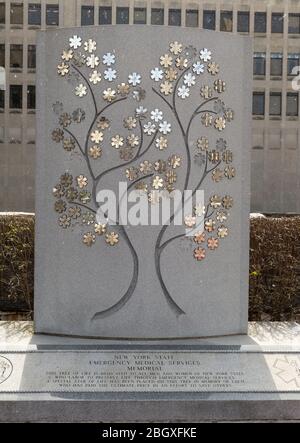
top-left (0, 322), bottom-right (300, 422)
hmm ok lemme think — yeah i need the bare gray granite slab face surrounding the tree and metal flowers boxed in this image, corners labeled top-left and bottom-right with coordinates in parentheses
top-left (35, 26), bottom-right (252, 339)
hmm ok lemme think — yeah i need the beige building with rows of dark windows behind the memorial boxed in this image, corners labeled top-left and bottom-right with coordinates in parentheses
top-left (0, 0), bottom-right (300, 212)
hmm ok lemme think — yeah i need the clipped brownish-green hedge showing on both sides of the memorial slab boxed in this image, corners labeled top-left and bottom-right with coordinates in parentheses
top-left (0, 215), bottom-right (300, 321)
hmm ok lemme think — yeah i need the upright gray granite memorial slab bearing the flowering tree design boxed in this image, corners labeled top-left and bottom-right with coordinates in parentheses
top-left (35, 26), bottom-right (252, 339)
